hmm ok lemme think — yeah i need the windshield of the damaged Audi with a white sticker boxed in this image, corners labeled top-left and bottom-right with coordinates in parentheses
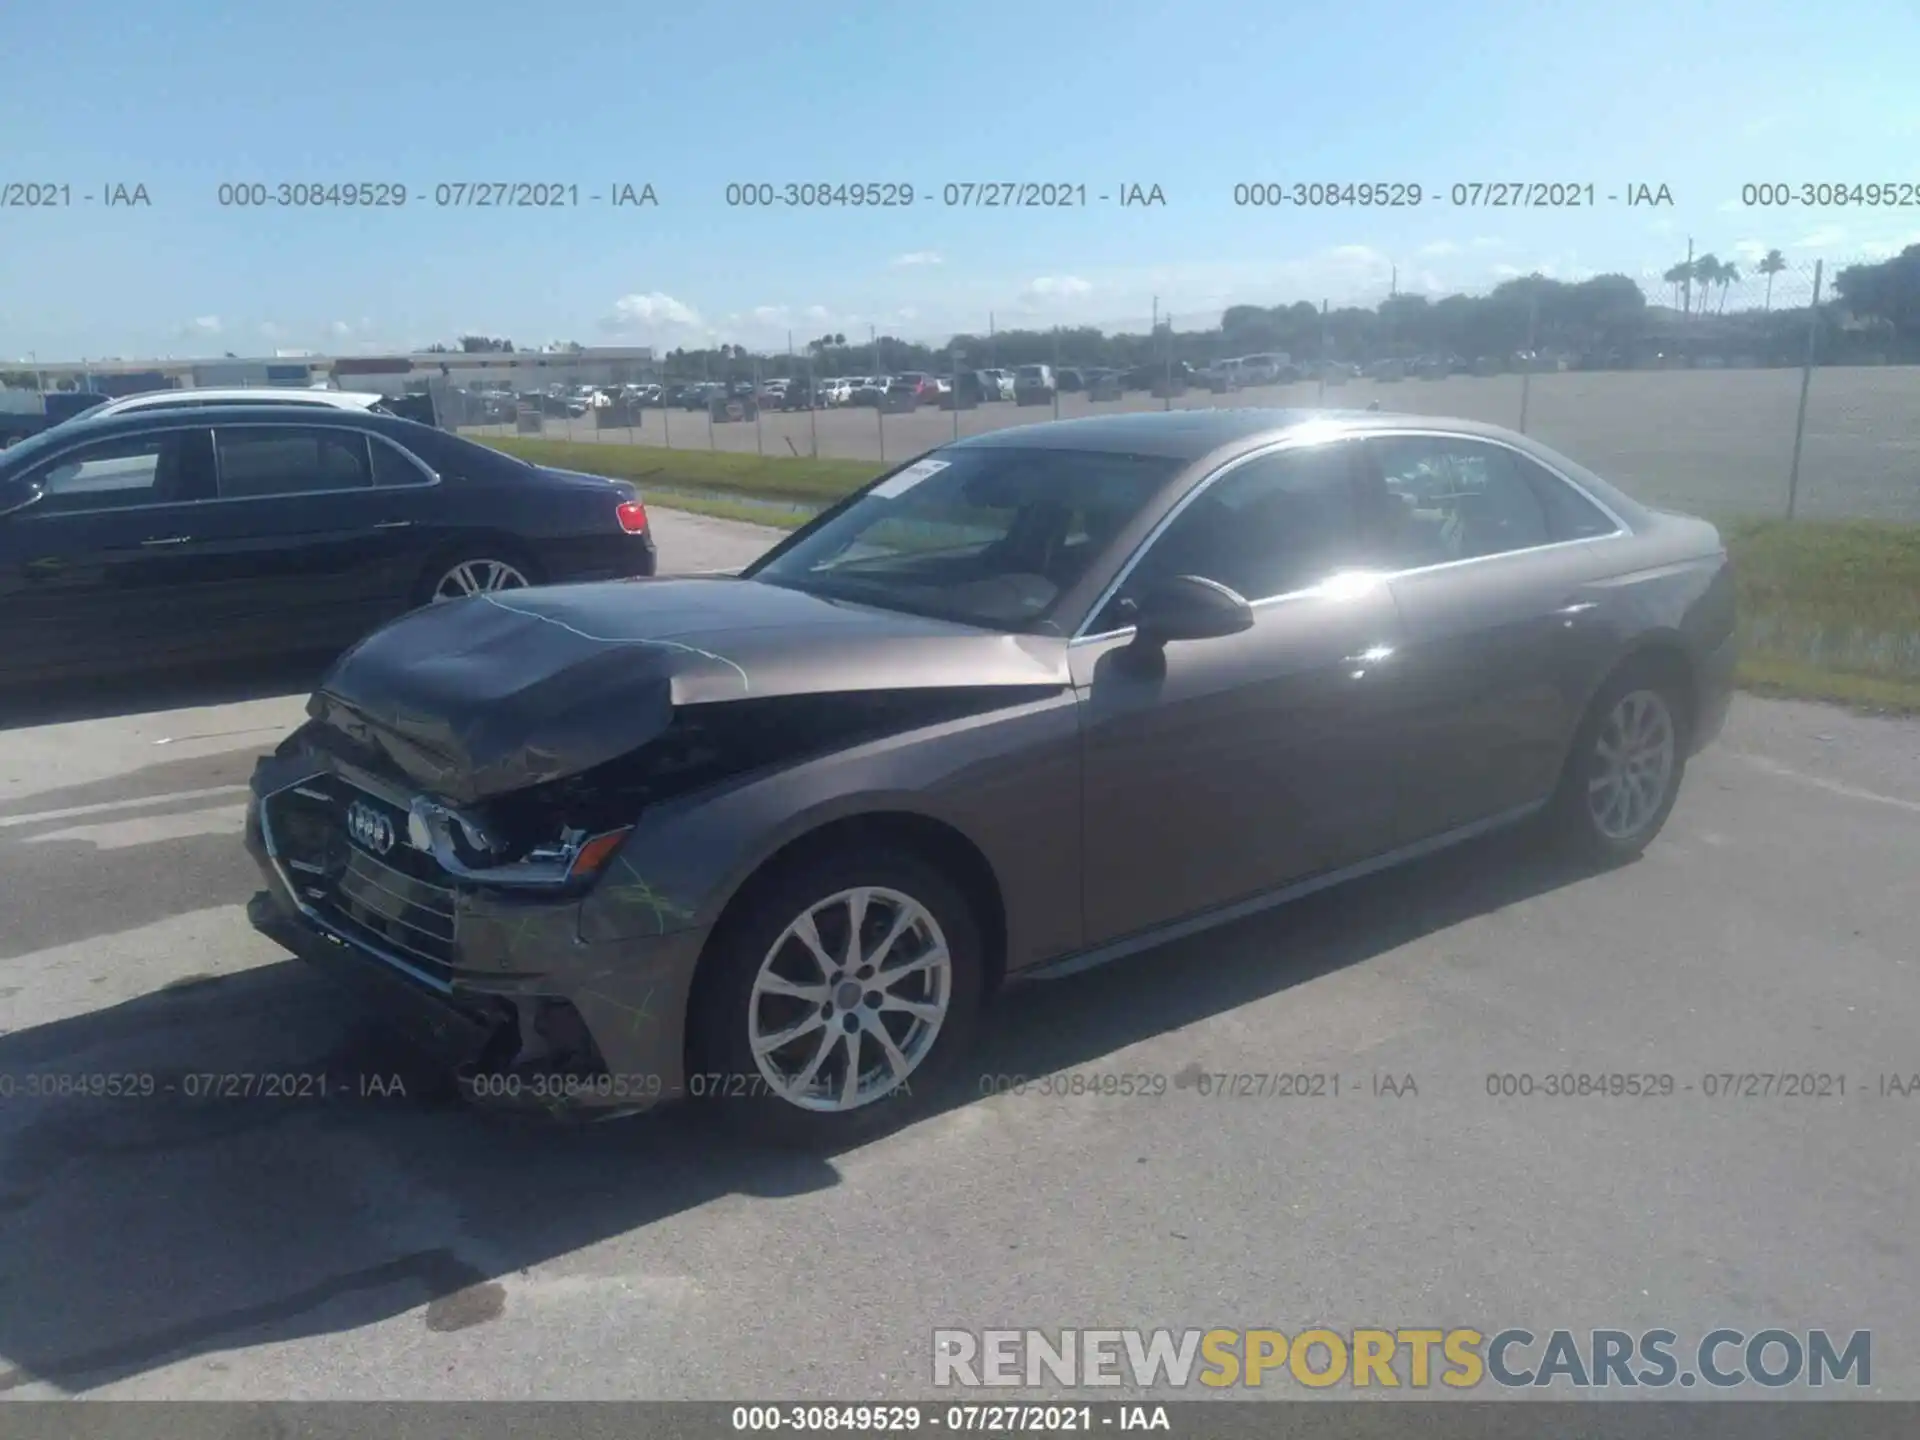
top-left (745, 445), bottom-right (1181, 632)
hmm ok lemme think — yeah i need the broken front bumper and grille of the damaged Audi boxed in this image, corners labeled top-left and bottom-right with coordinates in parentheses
top-left (246, 755), bottom-right (701, 1112)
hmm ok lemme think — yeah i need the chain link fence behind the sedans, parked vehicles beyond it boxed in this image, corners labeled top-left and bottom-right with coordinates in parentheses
top-left (434, 257), bottom-right (1920, 520)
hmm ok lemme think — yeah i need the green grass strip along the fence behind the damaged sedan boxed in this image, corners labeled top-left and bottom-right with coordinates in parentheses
top-left (488, 440), bottom-right (1920, 714)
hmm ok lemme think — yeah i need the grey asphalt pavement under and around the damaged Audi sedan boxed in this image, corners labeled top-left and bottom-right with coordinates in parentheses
top-left (0, 511), bottom-right (1920, 1400)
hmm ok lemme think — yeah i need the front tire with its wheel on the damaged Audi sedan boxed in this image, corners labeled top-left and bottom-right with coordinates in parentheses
top-left (687, 845), bottom-right (985, 1148)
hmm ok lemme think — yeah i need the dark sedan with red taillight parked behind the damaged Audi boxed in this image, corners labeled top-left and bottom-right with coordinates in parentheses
top-left (0, 405), bottom-right (655, 684)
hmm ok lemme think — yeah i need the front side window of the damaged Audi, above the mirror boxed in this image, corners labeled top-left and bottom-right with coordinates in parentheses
top-left (1094, 440), bottom-right (1365, 632)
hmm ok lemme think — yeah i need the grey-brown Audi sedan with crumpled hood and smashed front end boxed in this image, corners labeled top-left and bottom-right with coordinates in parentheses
top-left (248, 411), bottom-right (1734, 1142)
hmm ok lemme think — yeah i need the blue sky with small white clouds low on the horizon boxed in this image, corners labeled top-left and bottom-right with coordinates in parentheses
top-left (0, 0), bottom-right (1920, 361)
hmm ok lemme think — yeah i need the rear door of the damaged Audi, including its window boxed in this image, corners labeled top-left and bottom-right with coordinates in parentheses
top-left (1365, 432), bottom-right (1622, 843)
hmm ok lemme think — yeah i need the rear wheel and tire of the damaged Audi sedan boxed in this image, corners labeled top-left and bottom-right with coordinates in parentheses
top-left (1548, 660), bottom-right (1690, 866)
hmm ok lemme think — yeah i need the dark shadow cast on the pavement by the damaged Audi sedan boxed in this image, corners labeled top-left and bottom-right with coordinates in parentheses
top-left (0, 821), bottom-right (1580, 1392)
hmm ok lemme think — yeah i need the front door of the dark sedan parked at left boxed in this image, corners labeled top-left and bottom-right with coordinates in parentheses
top-left (0, 426), bottom-right (219, 678)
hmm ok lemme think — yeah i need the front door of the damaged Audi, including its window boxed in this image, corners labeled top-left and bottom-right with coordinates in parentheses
top-left (1071, 442), bottom-right (1400, 945)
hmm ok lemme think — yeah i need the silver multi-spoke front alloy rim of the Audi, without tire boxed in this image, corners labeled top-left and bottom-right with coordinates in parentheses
top-left (747, 887), bottom-right (952, 1112)
